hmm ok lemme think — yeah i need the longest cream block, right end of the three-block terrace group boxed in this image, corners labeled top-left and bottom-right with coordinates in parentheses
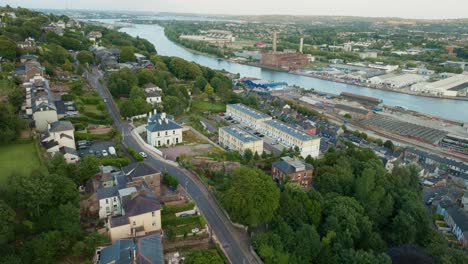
top-left (260, 120), bottom-right (320, 158)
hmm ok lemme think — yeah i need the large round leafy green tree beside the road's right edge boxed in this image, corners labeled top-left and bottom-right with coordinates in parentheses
top-left (222, 167), bottom-right (279, 226)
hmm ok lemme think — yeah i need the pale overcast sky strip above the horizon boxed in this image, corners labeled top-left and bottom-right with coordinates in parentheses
top-left (0, 0), bottom-right (468, 19)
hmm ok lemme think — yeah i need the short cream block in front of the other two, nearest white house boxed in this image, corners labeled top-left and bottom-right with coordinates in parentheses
top-left (218, 126), bottom-right (263, 155)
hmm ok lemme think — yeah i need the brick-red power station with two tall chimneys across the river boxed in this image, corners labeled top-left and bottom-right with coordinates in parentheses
top-left (260, 32), bottom-right (309, 70)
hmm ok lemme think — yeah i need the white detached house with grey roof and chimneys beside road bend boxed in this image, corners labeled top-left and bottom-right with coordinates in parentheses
top-left (146, 110), bottom-right (182, 147)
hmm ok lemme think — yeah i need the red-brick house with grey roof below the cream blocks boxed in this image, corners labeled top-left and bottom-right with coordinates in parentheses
top-left (271, 157), bottom-right (314, 188)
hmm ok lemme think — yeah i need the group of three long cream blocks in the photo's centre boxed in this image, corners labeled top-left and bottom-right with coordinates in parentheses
top-left (219, 104), bottom-right (320, 158)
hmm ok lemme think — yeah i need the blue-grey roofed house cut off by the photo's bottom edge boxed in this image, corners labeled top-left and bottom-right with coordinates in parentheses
top-left (94, 234), bottom-right (164, 264)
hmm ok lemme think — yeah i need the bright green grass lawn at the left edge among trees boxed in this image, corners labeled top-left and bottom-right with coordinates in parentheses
top-left (0, 142), bottom-right (40, 184)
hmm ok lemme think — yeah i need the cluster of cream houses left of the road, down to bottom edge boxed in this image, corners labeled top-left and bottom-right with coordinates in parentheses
top-left (88, 163), bottom-right (164, 264)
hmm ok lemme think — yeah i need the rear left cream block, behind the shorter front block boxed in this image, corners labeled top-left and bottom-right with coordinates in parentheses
top-left (226, 104), bottom-right (272, 129)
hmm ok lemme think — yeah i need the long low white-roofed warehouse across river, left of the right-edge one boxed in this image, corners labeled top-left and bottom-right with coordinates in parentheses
top-left (370, 73), bottom-right (429, 88)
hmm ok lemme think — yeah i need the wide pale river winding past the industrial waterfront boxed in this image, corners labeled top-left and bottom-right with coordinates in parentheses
top-left (121, 24), bottom-right (468, 123)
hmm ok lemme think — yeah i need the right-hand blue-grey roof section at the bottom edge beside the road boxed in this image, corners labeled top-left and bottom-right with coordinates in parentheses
top-left (136, 234), bottom-right (164, 264)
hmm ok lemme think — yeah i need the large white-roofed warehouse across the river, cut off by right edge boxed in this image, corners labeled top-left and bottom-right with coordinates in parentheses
top-left (411, 74), bottom-right (468, 96)
